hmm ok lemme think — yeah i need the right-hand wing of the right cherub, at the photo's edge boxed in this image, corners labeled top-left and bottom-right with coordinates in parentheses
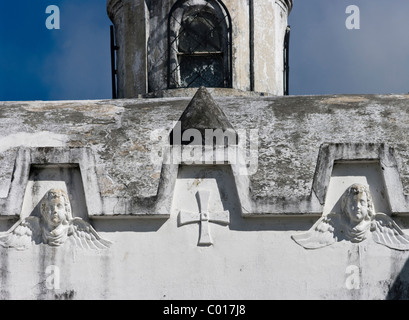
top-left (371, 213), bottom-right (409, 251)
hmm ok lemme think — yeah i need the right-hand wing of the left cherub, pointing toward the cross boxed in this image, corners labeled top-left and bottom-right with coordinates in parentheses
top-left (69, 218), bottom-right (112, 250)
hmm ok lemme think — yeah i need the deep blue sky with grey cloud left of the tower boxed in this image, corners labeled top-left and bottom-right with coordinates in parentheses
top-left (0, 0), bottom-right (111, 100)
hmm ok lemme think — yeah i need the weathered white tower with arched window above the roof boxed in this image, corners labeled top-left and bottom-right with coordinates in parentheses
top-left (107, 0), bottom-right (293, 98)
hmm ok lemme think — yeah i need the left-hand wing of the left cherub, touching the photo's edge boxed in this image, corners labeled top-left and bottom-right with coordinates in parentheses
top-left (0, 216), bottom-right (42, 250)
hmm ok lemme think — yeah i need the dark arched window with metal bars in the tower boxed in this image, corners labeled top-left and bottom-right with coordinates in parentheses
top-left (168, 0), bottom-right (231, 88)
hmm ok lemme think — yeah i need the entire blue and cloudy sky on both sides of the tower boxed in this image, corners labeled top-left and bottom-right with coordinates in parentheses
top-left (0, 0), bottom-right (409, 101)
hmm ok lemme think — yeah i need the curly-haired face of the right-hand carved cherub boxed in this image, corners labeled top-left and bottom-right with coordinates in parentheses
top-left (342, 184), bottom-right (374, 223)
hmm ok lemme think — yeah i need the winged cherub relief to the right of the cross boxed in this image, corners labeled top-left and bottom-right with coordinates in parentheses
top-left (291, 184), bottom-right (409, 250)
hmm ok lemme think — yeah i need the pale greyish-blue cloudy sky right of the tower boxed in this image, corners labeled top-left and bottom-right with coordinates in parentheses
top-left (289, 0), bottom-right (409, 95)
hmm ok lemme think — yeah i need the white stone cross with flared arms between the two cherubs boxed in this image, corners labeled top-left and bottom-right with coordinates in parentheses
top-left (179, 190), bottom-right (230, 246)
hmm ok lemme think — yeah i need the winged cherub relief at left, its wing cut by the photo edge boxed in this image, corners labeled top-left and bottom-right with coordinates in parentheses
top-left (0, 189), bottom-right (111, 250)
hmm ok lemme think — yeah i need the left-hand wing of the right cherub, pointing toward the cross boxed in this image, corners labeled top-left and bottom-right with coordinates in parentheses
top-left (291, 213), bottom-right (343, 249)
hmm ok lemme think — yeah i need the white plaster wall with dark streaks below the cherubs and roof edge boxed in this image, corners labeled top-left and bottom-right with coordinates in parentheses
top-left (0, 212), bottom-right (409, 299)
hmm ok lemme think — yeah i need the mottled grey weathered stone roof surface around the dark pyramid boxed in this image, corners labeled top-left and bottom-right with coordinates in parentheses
top-left (0, 89), bottom-right (409, 215)
